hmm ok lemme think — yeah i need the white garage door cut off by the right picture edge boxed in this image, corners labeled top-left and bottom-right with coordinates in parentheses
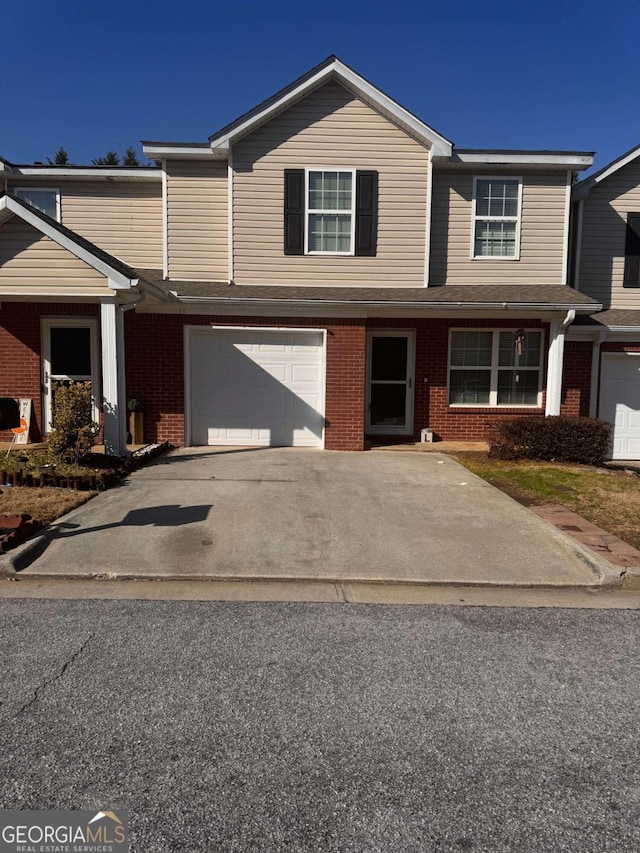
top-left (600, 354), bottom-right (640, 459)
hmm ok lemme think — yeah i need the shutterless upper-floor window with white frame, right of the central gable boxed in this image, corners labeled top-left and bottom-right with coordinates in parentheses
top-left (471, 178), bottom-right (522, 260)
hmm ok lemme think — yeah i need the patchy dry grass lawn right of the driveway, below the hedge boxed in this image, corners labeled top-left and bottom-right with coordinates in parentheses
top-left (455, 453), bottom-right (640, 549)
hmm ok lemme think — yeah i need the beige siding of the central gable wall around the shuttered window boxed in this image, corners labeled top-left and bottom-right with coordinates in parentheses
top-left (233, 83), bottom-right (428, 286)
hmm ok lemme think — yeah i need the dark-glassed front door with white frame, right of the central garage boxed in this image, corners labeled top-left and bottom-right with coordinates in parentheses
top-left (366, 331), bottom-right (415, 435)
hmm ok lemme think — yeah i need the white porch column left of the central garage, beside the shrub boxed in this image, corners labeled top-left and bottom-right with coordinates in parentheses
top-left (100, 299), bottom-right (127, 456)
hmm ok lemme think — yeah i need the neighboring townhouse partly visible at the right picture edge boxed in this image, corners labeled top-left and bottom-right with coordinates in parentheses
top-left (568, 147), bottom-right (640, 459)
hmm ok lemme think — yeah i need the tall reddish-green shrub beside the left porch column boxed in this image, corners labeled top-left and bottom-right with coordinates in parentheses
top-left (49, 382), bottom-right (100, 465)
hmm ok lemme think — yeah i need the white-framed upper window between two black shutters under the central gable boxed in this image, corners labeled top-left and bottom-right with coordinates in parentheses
top-left (306, 169), bottom-right (355, 255)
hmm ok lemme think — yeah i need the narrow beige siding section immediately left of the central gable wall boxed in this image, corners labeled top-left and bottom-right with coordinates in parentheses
top-left (167, 160), bottom-right (229, 281)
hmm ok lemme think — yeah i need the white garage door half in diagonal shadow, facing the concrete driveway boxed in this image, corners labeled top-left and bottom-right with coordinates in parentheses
top-left (188, 327), bottom-right (324, 447)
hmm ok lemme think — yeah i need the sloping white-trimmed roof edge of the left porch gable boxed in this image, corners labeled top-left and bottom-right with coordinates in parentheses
top-left (0, 192), bottom-right (138, 290)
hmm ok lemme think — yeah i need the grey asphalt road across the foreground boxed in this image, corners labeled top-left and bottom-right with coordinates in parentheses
top-left (0, 599), bottom-right (640, 853)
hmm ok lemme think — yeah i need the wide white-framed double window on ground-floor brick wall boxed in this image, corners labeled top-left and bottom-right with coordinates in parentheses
top-left (449, 329), bottom-right (543, 406)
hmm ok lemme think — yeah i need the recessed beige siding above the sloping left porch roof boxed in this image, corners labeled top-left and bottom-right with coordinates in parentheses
top-left (55, 178), bottom-right (162, 269)
